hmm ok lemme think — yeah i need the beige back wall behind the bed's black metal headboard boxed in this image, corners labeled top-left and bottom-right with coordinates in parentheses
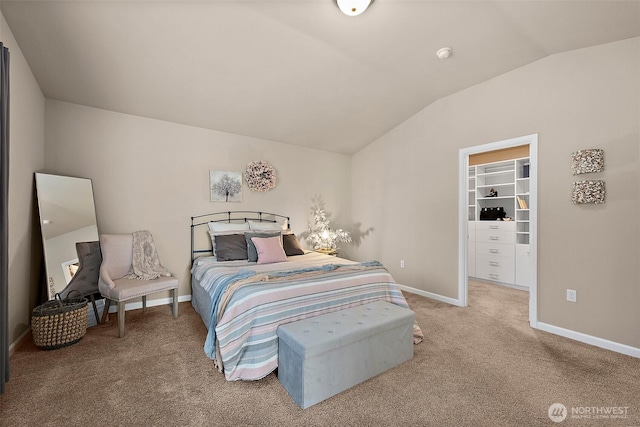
top-left (45, 100), bottom-right (349, 298)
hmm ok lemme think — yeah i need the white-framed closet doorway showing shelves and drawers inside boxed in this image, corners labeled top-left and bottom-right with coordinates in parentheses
top-left (458, 134), bottom-right (538, 328)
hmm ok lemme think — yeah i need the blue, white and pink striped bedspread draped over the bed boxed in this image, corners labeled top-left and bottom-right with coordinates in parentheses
top-left (192, 254), bottom-right (420, 381)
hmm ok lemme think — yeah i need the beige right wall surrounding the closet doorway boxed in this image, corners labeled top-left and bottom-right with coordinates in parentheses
top-left (351, 38), bottom-right (640, 348)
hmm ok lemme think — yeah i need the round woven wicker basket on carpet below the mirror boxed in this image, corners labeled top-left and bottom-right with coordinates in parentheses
top-left (31, 292), bottom-right (88, 350)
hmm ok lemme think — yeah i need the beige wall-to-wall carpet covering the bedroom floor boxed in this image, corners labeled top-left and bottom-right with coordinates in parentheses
top-left (0, 283), bottom-right (640, 426)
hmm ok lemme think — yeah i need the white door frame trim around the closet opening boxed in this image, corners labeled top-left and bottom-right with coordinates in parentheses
top-left (457, 134), bottom-right (538, 328)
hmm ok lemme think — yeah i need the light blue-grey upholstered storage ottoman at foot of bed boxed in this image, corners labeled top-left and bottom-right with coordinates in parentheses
top-left (278, 302), bottom-right (415, 409)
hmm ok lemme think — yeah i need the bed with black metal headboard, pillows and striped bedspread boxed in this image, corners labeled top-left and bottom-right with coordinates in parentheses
top-left (191, 211), bottom-right (422, 381)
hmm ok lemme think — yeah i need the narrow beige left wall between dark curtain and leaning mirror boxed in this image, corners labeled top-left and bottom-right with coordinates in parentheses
top-left (0, 13), bottom-right (44, 343)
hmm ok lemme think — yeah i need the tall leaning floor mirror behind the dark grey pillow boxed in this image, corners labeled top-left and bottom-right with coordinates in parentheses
top-left (35, 172), bottom-right (98, 299)
